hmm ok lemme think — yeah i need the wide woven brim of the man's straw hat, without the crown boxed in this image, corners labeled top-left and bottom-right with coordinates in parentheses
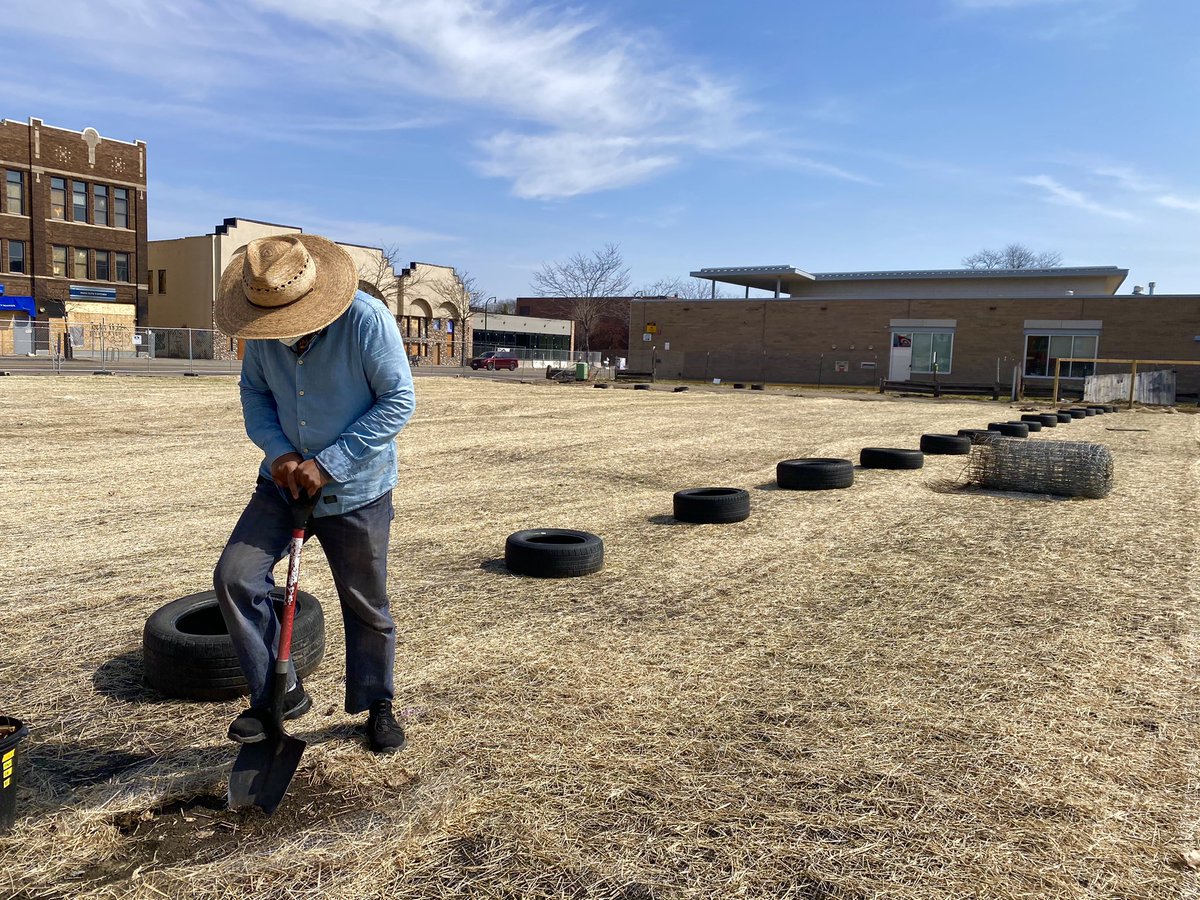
top-left (212, 234), bottom-right (359, 340)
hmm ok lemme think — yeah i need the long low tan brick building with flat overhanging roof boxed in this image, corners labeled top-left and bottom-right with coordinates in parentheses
top-left (629, 266), bottom-right (1200, 392)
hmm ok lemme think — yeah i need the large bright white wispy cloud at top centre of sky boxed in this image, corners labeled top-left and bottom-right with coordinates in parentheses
top-left (249, 0), bottom-right (748, 199)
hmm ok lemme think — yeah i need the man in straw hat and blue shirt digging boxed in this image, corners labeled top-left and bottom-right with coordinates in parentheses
top-left (212, 234), bottom-right (414, 752)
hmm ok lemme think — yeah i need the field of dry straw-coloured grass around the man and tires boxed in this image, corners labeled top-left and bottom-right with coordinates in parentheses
top-left (0, 377), bottom-right (1200, 900)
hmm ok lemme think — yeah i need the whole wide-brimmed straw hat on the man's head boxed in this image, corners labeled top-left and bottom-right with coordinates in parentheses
top-left (214, 234), bottom-right (359, 340)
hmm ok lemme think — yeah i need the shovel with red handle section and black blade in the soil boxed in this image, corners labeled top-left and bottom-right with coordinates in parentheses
top-left (229, 494), bottom-right (317, 816)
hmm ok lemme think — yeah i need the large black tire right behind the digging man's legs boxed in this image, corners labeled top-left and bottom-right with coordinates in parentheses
top-left (142, 589), bottom-right (325, 700)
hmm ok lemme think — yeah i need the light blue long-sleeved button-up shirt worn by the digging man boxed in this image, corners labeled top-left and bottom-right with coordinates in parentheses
top-left (238, 290), bottom-right (415, 516)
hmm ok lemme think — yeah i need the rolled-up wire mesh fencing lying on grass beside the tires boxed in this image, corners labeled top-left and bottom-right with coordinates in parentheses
top-left (966, 438), bottom-right (1112, 499)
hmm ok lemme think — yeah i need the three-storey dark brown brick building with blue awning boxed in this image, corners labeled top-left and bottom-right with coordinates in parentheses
top-left (0, 119), bottom-right (146, 354)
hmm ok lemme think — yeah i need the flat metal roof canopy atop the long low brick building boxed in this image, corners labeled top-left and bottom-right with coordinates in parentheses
top-left (691, 265), bottom-right (1129, 293)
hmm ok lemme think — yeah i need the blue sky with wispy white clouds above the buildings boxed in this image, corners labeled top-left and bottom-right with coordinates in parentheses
top-left (0, 0), bottom-right (1200, 298)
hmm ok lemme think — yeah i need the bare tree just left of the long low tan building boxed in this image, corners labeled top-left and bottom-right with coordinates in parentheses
top-left (533, 244), bottom-right (629, 353)
